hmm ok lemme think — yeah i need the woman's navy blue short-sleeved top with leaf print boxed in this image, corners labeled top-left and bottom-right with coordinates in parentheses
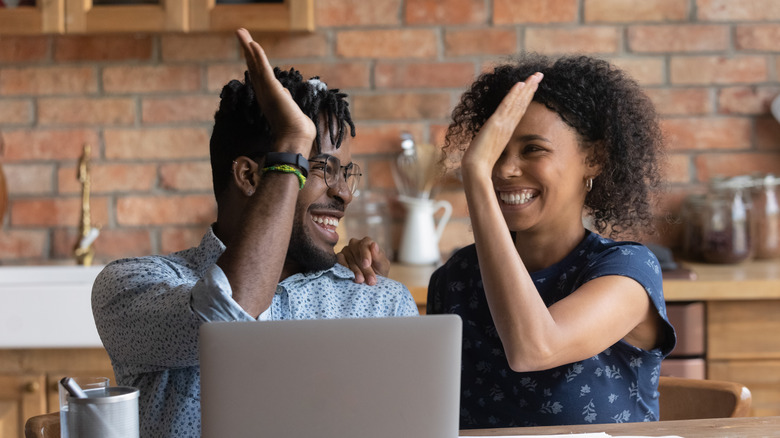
top-left (427, 231), bottom-right (676, 429)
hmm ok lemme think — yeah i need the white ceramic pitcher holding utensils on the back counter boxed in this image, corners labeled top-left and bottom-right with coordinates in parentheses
top-left (398, 196), bottom-right (452, 265)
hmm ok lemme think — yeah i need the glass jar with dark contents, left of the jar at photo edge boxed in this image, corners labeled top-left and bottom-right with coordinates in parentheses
top-left (701, 177), bottom-right (752, 263)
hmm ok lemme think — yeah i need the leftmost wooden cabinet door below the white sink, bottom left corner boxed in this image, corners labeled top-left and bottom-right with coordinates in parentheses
top-left (0, 374), bottom-right (46, 437)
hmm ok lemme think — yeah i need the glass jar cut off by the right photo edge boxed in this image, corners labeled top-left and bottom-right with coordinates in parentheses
top-left (751, 174), bottom-right (780, 259)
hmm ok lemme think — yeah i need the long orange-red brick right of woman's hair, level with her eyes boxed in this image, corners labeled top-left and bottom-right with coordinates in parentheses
top-left (661, 118), bottom-right (751, 151)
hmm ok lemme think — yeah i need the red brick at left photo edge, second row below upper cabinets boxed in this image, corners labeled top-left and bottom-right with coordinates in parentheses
top-left (0, 65), bottom-right (97, 96)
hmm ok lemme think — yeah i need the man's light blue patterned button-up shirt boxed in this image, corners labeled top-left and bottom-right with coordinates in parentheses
top-left (92, 229), bottom-right (418, 438)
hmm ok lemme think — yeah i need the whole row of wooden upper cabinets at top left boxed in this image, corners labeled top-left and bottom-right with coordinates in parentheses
top-left (0, 0), bottom-right (314, 35)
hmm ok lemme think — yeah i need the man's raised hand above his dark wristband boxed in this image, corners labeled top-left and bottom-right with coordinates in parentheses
top-left (236, 29), bottom-right (317, 157)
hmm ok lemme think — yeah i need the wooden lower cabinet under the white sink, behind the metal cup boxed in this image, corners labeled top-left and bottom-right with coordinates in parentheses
top-left (0, 348), bottom-right (116, 437)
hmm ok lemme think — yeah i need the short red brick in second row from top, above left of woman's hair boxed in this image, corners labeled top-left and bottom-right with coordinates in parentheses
top-left (444, 28), bottom-right (517, 57)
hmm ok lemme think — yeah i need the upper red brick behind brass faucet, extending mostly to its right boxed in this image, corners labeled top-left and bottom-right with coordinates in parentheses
top-left (57, 162), bottom-right (157, 194)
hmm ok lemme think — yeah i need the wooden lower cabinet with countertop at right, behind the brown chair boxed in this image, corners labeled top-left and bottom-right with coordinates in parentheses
top-left (664, 260), bottom-right (780, 416)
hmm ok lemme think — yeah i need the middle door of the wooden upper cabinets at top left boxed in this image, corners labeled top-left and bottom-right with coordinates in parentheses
top-left (66, 0), bottom-right (187, 33)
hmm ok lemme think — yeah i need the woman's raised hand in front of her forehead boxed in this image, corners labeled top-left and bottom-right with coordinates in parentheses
top-left (461, 73), bottom-right (543, 177)
